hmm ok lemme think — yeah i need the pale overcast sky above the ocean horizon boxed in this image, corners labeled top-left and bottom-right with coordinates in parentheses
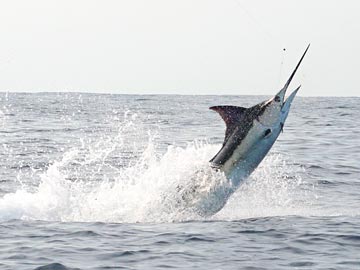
top-left (0, 0), bottom-right (360, 96)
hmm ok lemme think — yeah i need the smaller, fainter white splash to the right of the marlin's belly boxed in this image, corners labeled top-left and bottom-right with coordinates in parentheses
top-left (214, 154), bottom-right (316, 220)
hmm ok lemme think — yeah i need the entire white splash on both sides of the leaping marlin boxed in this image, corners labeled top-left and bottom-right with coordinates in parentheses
top-left (0, 113), bottom-right (320, 223)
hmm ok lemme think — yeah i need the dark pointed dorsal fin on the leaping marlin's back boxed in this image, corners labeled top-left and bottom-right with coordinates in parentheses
top-left (209, 105), bottom-right (247, 143)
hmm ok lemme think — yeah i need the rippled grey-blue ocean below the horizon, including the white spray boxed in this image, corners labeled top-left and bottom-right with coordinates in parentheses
top-left (0, 93), bottom-right (360, 270)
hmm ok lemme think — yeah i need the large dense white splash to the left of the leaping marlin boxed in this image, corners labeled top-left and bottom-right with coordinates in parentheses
top-left (0, 138), bottom-right (222, 222)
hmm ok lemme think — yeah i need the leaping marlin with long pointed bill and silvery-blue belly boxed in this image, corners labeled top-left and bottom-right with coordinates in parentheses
top-left (176, 44), bottom-right (310, 216)
